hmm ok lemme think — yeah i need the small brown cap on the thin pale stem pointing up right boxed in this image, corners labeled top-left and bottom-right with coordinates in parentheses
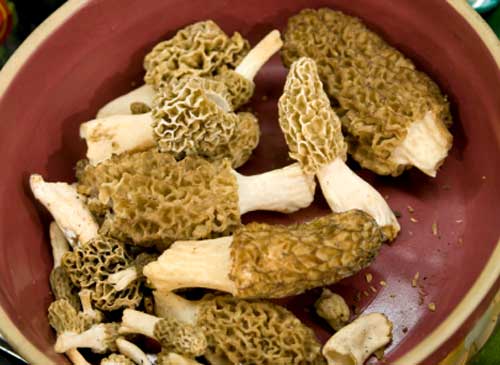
top-left (214, 67), bottom-right (255, 110)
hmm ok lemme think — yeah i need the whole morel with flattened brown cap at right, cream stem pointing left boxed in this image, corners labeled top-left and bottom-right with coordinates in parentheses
top-left (143, 210), bottom-right (382, 298)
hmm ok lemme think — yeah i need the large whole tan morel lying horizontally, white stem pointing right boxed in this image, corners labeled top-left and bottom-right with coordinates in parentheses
top-left (77, 150), bottom-right (314, 247)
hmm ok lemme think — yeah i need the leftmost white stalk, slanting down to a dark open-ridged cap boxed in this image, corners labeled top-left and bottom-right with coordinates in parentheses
top-left (30, 174), bottom-right (98, 246)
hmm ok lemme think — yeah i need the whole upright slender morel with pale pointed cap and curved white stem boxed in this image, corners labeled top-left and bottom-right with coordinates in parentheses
top-left (278, 57), bottom-right (400, 240)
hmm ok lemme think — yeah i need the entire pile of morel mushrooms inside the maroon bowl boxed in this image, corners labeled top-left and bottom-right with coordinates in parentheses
top-left (30, 9), bottom-right (452, 365)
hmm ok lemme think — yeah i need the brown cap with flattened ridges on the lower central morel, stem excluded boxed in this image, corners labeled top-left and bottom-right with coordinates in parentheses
top-left (229, 210), bottom-right (382, 298)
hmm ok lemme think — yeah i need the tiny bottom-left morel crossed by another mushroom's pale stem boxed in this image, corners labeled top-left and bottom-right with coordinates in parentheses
top-left (48, 299), bottom-right (90, 365)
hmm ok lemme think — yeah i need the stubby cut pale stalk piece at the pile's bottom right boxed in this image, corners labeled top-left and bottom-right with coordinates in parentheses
top-left (322, 313), bottom-right (392, 365)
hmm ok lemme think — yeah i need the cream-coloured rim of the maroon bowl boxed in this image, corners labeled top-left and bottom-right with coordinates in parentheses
top-left (0, 0), bottom-right (500, 365)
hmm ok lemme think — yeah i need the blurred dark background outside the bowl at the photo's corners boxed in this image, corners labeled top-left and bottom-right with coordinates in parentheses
top-left (0, 0), bottom-right (500, 365)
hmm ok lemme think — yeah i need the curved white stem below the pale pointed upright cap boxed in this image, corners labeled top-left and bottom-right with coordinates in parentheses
top-left (316, 157), bottom-right (400, 240)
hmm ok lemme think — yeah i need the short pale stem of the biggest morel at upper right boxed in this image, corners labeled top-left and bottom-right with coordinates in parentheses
top-left (390, 111), bottom-right (453, 177)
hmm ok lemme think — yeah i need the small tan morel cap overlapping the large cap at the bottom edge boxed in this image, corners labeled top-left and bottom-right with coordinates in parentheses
top-left (154, 318), bottom-right (207, 357)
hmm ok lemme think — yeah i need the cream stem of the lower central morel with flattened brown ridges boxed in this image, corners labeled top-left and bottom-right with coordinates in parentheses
top-left (144, 237), bottom-right (236, 294)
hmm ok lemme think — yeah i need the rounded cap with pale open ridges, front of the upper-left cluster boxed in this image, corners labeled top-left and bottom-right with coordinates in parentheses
top-left (152, 77), bottom-right (238, 158)
